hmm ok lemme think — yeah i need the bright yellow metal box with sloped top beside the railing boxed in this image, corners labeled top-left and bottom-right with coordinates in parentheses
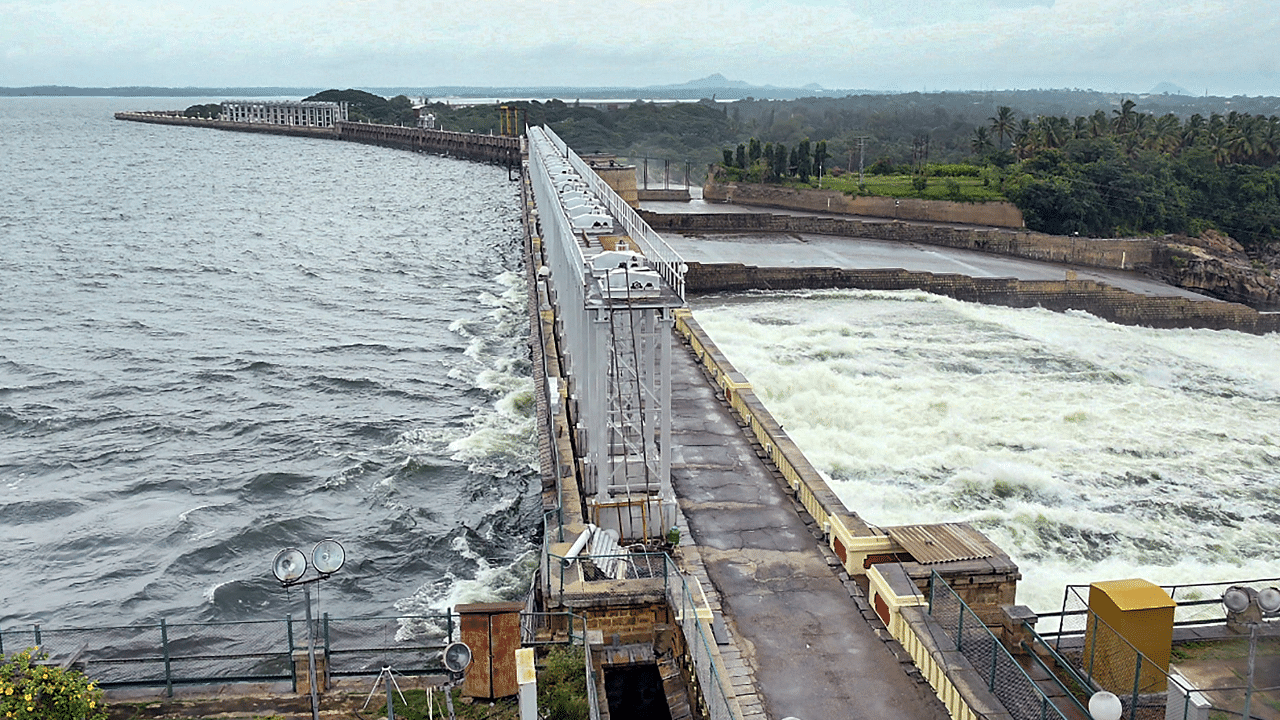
top-left (1082, 579), bottom-right (1178, 697)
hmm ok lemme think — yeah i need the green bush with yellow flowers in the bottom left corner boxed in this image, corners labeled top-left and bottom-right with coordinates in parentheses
top-left (0, 648), bottom-right (106, 720)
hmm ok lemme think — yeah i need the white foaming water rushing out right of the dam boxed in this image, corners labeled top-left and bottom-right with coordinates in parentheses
top-left (695, 291), bottom-right (1280, 611)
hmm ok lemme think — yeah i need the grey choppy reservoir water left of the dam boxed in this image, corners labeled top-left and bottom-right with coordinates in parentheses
top-left (0, 99), bottom-right (540, 626)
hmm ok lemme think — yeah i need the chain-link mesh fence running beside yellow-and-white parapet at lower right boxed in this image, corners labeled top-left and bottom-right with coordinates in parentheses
top-left (929, 573), bottom-right (1066, 720)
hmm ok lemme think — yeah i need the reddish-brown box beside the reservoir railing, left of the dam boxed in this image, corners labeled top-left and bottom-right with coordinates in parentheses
top-left (453, 602), bottom-right (525, 700)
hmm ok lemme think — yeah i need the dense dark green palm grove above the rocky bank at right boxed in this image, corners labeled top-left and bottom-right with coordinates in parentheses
top-left (970, 100), bottom-right (1280, 250)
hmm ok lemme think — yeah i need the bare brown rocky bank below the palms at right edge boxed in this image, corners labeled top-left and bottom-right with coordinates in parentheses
top-left (1149, 231), bottom-right (1280, 310)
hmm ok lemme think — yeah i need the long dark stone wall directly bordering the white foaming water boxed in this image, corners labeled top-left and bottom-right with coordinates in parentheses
top-left (685, 263), bottom-right (1280, 334)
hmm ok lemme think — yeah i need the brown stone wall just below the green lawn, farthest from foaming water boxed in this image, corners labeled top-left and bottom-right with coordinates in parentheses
top-left (703, 179), bottom-right (1024, 228)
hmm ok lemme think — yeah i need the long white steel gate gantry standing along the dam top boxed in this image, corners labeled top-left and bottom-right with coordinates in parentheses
top-left (527, 127), bottom-right (687, 541)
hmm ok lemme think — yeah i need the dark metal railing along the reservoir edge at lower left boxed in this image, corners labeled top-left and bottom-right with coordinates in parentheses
top-left (0, 614), bottom-right (457, 689)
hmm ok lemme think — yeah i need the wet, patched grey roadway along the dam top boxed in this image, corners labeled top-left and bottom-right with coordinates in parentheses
top-left (672, 337), bottom-right (947, 720)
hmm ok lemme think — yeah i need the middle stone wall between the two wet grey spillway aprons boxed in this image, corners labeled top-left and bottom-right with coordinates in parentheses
top-left (640, 210), bottom-right (1158, 269)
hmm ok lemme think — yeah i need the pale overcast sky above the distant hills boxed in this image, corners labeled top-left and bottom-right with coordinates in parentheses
top-left (0, 0), bottom-right (1280, 95)
